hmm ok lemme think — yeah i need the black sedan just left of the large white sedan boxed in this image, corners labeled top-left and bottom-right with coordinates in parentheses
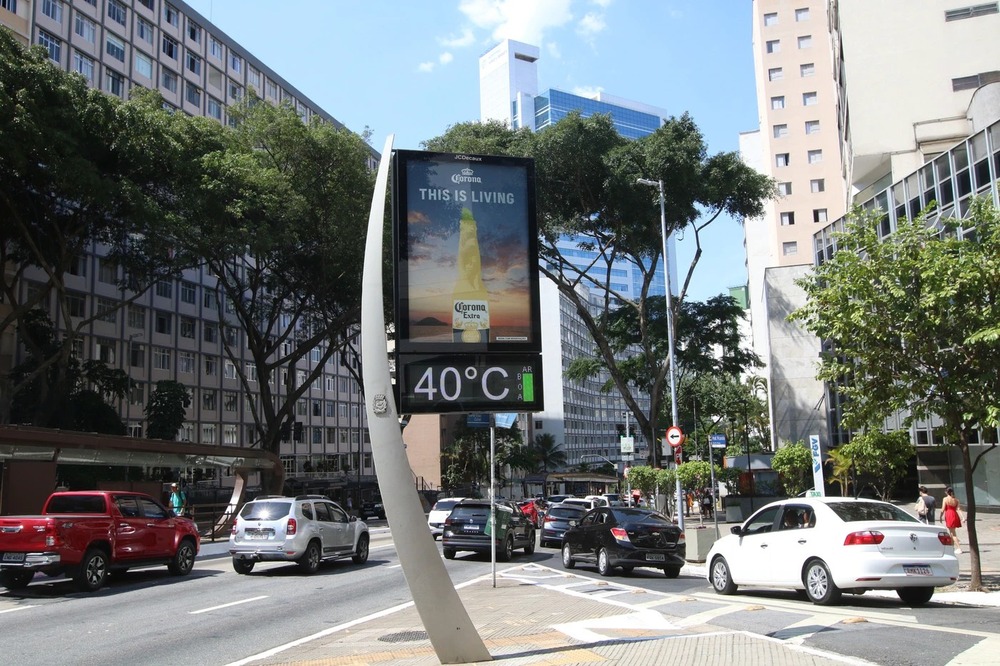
top-left (562, 506), bottom-right (687, 578)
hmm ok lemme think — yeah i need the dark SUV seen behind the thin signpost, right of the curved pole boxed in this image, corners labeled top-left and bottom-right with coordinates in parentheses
top-left (441, 500), bottom-right (535, 562)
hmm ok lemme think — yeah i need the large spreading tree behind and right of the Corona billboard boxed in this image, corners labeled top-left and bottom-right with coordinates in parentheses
top-left (424, 113), bottom-right (773, 465)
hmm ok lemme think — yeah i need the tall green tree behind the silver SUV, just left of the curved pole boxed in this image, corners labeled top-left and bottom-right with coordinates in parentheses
top-left (184, 97), bottom-right (374, 483)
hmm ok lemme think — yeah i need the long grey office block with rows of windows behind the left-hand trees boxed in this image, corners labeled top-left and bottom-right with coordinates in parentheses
top-left (0, 0), bottom-right (388, 488)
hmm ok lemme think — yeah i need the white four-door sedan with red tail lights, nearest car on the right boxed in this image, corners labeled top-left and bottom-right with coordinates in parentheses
top-left (706, 497), bottom-right (958, 605)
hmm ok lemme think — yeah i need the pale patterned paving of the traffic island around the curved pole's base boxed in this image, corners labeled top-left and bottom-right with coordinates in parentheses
top-left (223, 514), bottom-right (1000, 666)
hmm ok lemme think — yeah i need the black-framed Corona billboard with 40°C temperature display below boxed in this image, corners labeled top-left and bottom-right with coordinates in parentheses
top-left (392, 150), bottom-right (541, 413)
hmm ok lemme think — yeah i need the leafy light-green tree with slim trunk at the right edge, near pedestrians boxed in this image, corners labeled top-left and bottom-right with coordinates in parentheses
top-left (792, 200), bottom-right (1000, 589)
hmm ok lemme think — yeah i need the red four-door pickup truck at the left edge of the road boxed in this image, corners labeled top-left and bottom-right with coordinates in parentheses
top-left (0, 490), bottom-right (201, 592)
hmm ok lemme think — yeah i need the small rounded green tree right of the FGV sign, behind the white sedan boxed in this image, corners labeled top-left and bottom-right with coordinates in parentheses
top-left (840, 430), bottom-right (917, 502)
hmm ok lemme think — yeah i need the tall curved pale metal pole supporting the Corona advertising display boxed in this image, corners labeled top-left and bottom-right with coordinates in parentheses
top-left (361, 135), bottom-right (492, 664)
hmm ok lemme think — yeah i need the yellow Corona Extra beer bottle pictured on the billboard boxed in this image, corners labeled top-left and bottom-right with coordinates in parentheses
top-left (451, 208), bottom-right (490, 342)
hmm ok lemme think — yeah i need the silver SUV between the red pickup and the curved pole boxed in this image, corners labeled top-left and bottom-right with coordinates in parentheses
top-left (229, 495), bottom-right (371, 574)
